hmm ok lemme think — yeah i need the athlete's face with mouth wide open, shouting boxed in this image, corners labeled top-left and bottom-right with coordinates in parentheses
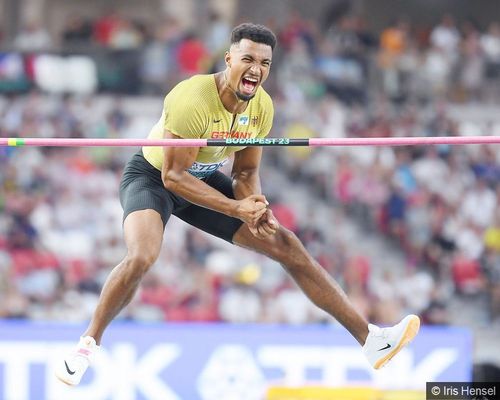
top-left (225, 39), bottom-right (273, 101)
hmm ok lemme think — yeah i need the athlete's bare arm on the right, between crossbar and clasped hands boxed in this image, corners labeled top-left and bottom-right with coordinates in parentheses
top-left (231, 147), bottom-right (262, 200)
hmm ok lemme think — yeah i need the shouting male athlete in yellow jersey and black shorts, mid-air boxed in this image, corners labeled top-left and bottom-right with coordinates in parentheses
top-left (56, 23), bottom-right (420, 385)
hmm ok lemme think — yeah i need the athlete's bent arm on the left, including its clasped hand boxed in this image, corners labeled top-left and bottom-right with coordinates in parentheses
top-left (161, 131), bottom-right (266, 224)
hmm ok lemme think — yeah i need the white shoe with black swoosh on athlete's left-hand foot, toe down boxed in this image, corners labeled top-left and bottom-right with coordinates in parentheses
top-left (55, 336), bottom-right (99, 386)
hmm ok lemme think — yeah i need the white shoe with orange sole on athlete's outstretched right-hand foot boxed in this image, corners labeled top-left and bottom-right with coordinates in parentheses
top-left (363, 314), bottom-right (420, 369)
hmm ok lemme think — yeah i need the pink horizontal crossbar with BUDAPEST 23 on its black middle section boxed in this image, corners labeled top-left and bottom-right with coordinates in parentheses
top-left (0, 136), bottom-right (500, 147)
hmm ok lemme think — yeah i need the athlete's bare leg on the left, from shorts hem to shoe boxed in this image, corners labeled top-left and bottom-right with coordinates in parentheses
top-left (83, 210), bottom-right (163, 345)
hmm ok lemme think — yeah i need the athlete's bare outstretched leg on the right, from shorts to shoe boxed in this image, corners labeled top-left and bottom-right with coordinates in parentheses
top-left (233, 224), bottom-right (368, 345)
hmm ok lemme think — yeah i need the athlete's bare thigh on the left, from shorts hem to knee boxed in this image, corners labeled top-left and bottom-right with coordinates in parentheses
top-left (123, 209), bottom-right (164, 263)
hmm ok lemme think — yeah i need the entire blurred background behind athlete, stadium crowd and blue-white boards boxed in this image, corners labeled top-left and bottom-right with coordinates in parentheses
top-left (0, 0), bottom-right (500, 400)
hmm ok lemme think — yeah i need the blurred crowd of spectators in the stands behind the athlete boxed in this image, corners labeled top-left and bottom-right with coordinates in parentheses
top-left (0, 10), bottom-right (500, 332)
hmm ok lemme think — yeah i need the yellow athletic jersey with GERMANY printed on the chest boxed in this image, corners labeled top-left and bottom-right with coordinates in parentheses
top-left (142, 74), bottom-right (274, 178)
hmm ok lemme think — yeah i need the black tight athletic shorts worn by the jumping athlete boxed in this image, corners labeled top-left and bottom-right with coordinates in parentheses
top-left (120, 151), bottom-right (243, 243)
